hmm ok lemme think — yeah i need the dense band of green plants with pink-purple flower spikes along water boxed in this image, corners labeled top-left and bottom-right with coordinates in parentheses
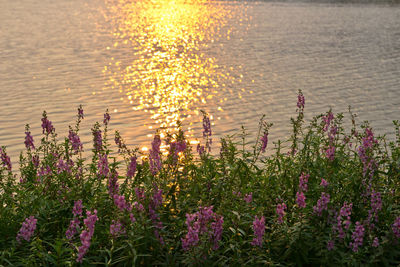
top-left (0, 91), bottom-right (400, 266)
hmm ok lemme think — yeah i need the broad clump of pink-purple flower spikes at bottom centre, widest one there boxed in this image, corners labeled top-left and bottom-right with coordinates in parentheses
top-left (182, 206), bottom-right (224, 251)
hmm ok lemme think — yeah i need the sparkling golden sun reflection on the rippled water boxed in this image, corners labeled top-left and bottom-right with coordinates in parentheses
top-left (103, 0), bottom-right (244, 147)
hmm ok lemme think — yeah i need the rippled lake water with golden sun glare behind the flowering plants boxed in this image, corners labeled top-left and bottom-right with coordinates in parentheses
top-left (0, 0), bottom-right (400, 165)
